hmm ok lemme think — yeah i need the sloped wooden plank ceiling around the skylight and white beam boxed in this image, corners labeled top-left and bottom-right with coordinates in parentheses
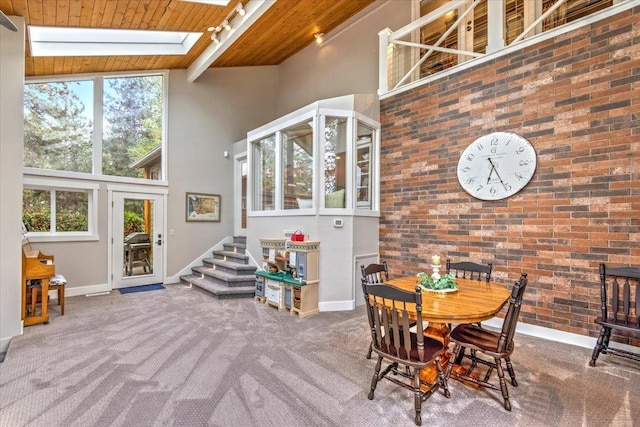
top-left (0, 0), bottom-right (374, 76)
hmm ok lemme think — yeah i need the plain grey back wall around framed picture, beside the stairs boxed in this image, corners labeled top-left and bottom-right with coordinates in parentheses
top-left (167, 66), bottom-right (278, 276)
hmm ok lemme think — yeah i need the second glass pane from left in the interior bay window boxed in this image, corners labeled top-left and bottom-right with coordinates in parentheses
top-left (282, 122), bottom-right (313, 209)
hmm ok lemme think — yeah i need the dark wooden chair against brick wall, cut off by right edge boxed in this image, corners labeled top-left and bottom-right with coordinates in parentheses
top-left (589, 263), bottom-right (640, 366)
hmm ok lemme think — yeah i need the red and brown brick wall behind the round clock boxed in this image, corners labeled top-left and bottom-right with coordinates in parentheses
top-left (380, 7), bottom-right (640, 342)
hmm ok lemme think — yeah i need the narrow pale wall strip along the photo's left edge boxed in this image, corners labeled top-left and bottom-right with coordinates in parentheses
top-left (0, 16), bottom-right (24, 354)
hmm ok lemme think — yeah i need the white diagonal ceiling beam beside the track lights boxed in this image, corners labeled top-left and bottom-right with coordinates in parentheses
top-left (187, 0), bottom-right (276, 83)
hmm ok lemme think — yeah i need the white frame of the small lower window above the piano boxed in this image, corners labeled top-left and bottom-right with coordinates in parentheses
top-left (22, 177), bottom-right (100, 242)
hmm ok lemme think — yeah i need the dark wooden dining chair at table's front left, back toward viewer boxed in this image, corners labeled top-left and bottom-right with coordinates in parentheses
top-left (362, 281), bottom-right (450, 425)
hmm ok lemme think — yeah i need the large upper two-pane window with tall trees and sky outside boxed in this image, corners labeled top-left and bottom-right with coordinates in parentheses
top-left (24, 75), bottom-right (165, 180)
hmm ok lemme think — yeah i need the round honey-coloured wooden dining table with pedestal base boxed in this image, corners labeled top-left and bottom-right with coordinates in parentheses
top-left (385, 276), bottom-right (511, 383)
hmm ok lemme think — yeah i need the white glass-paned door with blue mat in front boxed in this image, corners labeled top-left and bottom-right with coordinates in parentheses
top-left (111, 192), bottom-right (165, 289)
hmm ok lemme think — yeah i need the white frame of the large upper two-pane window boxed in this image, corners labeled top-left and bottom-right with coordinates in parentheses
top-left (24, 70), bottom-right (169, 186)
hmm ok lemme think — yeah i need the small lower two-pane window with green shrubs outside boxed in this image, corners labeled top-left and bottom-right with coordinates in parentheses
top-left (22, 179), bottom-right (98, 241)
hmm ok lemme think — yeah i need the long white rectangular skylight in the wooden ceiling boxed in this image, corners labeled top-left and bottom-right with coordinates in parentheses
top-left (29, 26), bottom-right (202, 56)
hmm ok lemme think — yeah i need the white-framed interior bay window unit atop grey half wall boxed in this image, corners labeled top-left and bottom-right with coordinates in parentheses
top-left (247, 97), bottom-right (380, 217)
